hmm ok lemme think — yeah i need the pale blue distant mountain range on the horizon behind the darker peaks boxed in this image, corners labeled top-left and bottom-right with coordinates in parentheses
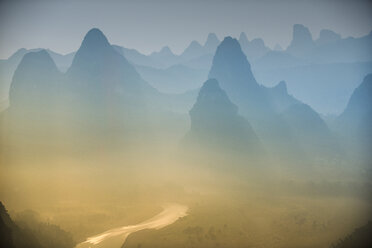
top-left (0, 24), bottom-right (372, 115)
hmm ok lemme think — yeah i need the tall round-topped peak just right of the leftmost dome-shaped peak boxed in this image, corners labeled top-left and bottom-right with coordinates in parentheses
top-left (66, 29), bottom-right (153, 108)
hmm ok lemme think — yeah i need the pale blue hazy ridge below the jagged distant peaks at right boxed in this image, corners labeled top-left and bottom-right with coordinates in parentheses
top-left (252, 56), bottom-right (372, 114)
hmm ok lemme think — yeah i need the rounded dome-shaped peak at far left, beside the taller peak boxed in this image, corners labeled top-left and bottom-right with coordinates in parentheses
top-left (9, 50), bottom-right (61, 111)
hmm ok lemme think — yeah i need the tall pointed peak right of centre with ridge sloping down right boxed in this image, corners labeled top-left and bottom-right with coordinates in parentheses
top-left (209, 37), bottom-right (334, 161)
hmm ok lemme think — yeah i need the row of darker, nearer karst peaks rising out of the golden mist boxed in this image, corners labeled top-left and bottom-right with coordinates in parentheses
top-left (1, 26), bottom-right (371, 165)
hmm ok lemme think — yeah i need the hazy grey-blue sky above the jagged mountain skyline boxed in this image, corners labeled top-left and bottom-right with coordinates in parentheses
top-left (0, 0), bottom-right (372, 58)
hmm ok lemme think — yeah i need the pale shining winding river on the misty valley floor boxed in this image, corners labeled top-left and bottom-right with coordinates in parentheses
top-left (75, 204), bottom-right (188, 248)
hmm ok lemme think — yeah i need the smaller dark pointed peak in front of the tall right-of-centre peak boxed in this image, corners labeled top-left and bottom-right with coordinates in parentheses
top-left (186, 79), bottom-right (260, 153)
